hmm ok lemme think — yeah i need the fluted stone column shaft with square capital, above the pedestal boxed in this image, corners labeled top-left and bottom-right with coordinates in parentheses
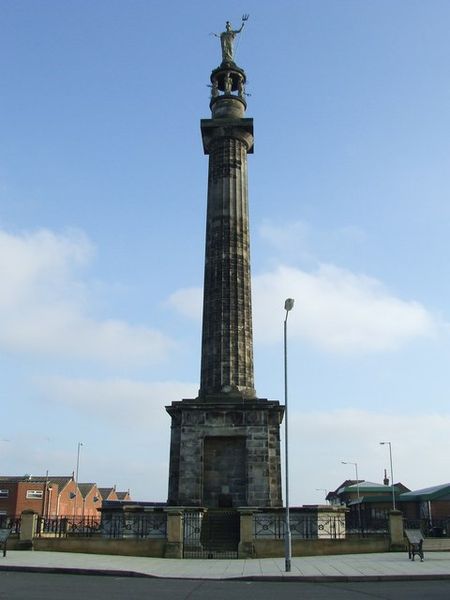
top-left (200, 86), bottom-right (255, 398)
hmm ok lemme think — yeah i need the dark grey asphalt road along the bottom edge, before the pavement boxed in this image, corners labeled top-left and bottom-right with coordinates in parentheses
top-left (0, 572), bottom-right (450, 600)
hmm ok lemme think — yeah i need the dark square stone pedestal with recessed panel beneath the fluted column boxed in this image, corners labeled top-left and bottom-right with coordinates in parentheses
top-left (166, 394), bottom-right (284, 507)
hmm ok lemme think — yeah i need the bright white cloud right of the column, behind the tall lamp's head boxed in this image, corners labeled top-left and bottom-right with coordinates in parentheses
top-left (253, 265), bottom-right (438, 353)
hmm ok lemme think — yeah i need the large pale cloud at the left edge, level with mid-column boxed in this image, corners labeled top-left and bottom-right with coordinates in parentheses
top-left (0, 230), bottom-right (173, 364)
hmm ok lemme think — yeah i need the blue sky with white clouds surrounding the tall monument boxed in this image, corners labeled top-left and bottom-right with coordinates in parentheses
top-left (0, 0), bottom-right (450, 504)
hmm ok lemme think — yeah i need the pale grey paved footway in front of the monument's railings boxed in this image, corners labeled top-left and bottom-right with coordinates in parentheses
top-left (0, 550), bottom-right (450, 581)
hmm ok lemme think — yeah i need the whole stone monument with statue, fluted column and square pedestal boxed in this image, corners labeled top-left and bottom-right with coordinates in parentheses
top-left (166, 24), bottom-right (284, 508)
